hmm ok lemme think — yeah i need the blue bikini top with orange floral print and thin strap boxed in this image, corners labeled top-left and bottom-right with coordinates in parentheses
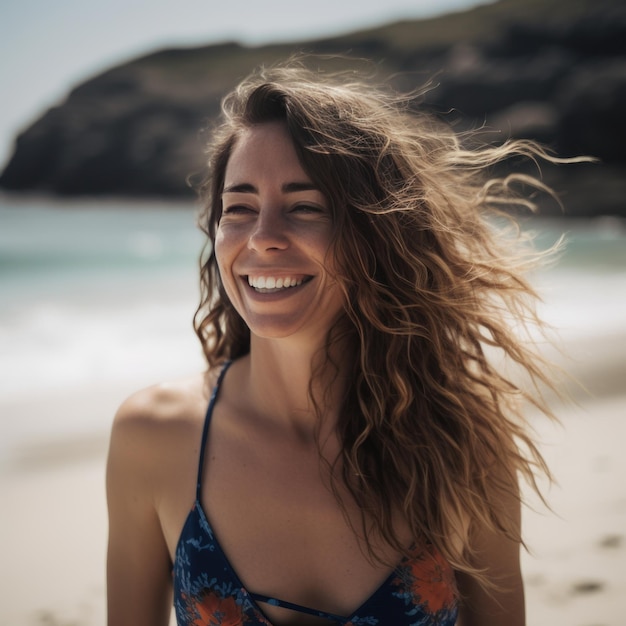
top-left (173, 364), bottom-right (458, 626)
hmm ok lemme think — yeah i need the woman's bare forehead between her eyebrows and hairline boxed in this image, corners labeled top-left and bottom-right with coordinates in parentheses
top-left (224, 122), bottom-right (309, 186)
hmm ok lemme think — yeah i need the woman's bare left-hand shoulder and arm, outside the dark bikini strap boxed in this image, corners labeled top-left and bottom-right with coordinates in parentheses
top-left (106, 374), bottom-right (219, 624)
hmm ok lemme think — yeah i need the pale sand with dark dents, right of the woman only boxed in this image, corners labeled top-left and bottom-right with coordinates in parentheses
top-left (523, 394), bottom-right (626, 626)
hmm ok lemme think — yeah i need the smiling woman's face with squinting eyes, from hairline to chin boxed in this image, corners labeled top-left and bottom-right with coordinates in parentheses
top-left (215, 122), bottom-right (343, 342)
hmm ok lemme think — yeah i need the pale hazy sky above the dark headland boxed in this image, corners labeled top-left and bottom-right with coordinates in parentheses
top-left (0, 0), bottom-right (484, 168)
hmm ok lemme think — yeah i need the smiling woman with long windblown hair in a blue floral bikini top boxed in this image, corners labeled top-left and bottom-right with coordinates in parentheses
top-left (107, 64), bottom-right (560, 626)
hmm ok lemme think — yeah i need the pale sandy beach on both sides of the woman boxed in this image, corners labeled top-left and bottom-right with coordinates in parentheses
top-left (0, 326), bottom-right (626, 626)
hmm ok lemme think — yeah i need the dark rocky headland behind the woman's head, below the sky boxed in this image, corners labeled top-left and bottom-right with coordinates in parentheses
top-left (0, 0), bottom-right (626, 215)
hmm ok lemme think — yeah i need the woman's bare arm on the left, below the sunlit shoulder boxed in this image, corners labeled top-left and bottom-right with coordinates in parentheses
top-left (107, 398), bottom-right (171, 626)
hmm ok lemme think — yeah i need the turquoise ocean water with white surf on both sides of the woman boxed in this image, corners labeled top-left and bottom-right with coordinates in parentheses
top-left (0, 198), bottom-right (626, 458)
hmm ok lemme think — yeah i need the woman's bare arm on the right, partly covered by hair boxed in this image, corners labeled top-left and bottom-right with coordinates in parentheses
top-left (457, 480), bottom-right (526, 626)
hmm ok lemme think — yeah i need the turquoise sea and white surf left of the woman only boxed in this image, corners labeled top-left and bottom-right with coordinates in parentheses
top-left (0, 201), bottom-right (203, 398)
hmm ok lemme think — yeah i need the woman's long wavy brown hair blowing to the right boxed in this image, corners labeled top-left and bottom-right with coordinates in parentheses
top-left (195, 64), bottom-right (555, 584)
